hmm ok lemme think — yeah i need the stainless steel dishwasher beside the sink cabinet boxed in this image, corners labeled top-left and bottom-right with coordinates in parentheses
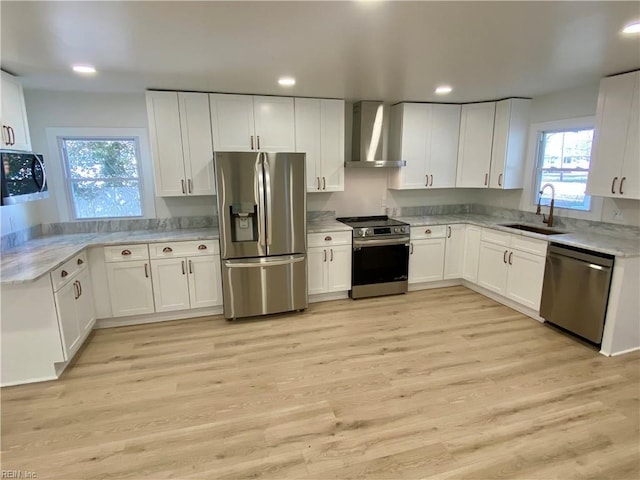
top-left (540, 243), bottom-right (614, 344)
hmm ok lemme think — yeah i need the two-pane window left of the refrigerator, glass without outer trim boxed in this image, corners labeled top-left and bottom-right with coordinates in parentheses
top-left (59, 137), bottom-right (143, 220)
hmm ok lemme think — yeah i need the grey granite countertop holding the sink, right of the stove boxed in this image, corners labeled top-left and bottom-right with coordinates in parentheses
top-left (394, 213), bottom-right (640, 257)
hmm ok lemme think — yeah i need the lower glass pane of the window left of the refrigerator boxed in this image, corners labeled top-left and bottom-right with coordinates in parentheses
top-left (71, 180), bottom-right (142, 218)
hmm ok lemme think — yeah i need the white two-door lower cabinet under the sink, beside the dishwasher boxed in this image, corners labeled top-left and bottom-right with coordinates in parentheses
top-left (478, 228), bottom-right (547, 312)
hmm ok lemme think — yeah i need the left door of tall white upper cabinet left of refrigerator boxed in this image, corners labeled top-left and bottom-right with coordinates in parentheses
top-left (147, 92), bottom-right (187, 197)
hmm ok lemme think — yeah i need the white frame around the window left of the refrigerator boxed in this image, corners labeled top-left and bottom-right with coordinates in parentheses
top-left (43, 127), bottom-right (156, 223)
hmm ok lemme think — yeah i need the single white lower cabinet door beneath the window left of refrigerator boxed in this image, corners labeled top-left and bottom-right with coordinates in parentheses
top-left (107, 260), bottom-right (154, 317)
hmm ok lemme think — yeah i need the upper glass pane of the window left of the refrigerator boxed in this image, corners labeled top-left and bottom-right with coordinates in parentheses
top-left (64, 139), bottom-right (138, 179)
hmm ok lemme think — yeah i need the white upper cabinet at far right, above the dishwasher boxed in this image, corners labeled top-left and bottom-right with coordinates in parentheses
top-left (587, 71), bottom-right (640, 199)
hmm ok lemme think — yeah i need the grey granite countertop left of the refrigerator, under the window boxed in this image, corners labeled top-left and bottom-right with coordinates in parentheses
top-left (0, 227), bottom-right (218, 284)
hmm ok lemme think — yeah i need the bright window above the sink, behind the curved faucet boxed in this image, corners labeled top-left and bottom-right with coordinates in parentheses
top-left (534, 128), bottom-right (593, 210)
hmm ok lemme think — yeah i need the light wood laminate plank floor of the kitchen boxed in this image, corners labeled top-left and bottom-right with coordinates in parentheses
top-left (2, 287), bottom-right (640, 480)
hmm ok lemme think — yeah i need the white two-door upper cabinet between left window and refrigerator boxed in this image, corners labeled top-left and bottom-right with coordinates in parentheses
top-left (147, 91), bottom-right (215, 197)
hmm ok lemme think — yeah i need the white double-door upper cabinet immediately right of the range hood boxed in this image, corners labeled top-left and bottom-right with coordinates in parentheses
top-left (389, 103), bottom-right (461, 189)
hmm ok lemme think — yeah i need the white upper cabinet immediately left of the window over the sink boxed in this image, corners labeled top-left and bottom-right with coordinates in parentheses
top-left (489, 98), bottom-right (531, 189)
